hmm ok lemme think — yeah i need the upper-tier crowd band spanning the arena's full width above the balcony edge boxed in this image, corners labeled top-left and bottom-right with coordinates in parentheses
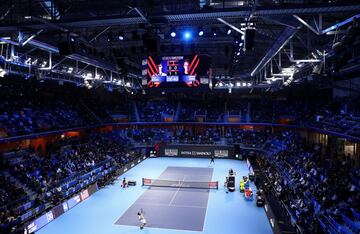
top-left (0, 85), bottom-right (360, 138)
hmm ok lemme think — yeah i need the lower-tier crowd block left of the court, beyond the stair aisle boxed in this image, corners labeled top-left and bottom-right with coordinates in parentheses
top-left (10, 135), bottom-right (111, 197)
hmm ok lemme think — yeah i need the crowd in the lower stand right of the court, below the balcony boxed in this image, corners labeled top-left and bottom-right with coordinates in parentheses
top-left (258, 135), bottom-right (360, 233)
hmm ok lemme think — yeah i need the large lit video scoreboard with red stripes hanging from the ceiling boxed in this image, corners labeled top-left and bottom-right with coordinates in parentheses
top-left (146, 55), bottom-right (200, 88)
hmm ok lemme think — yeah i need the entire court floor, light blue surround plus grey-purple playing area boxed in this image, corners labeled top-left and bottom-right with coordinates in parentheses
top-left (37, 158), bottom-right (272, 234)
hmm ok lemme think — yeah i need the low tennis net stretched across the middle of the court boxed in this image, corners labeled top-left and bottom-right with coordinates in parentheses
top-left (142, 178), bottom-right (219, 189)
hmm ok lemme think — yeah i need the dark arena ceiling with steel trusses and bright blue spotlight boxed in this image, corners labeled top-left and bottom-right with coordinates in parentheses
top-left (0, 0), bottom-right (360, 91)
